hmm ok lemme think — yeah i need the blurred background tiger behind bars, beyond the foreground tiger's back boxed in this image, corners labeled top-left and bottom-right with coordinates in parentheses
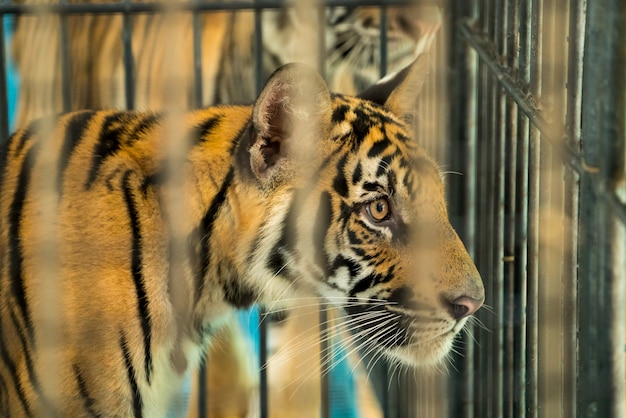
top-left (7, 2), bottom-right (441, 417)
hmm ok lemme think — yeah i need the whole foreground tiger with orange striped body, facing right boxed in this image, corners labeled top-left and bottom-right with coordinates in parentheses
top-left (0, 54), bottom-right (485, 417)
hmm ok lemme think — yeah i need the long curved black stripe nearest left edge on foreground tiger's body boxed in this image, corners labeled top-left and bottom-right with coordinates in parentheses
top-left (8, 144), bottom-right (39, 349)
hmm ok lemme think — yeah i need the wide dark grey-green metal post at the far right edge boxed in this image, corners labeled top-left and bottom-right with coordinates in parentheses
top-left (578, 0), bottom-right (626, 417)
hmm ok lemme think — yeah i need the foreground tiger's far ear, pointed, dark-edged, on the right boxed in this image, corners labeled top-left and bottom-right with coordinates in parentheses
top-left (359, 54), bottom-right (429, 124)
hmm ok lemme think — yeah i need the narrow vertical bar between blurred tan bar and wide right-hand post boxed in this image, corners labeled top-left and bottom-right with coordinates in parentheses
top-left (561, 0), bottom-right (587, 417)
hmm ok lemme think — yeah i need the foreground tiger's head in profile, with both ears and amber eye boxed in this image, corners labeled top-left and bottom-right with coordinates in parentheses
top-left (237, 54), bottom-right (484, 365)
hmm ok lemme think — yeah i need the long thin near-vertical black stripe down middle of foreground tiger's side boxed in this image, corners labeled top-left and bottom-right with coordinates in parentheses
top-left (122, 171), bottom-right (152, 384)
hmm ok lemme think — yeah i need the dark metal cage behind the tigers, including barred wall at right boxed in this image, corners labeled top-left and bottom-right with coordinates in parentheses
top-left (0, 0), bottom-right (626, 418)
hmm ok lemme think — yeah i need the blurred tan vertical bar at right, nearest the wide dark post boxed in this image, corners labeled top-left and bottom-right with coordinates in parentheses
top-left (529, 0), bottom-right (570, 418)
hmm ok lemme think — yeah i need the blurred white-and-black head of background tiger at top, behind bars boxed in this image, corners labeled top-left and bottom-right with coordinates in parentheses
top-left (263, 1), bottom-right (441, 94)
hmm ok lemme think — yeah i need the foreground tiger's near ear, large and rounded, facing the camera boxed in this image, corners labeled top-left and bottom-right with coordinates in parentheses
top-left (249, 64), bottom-right (331, 185)
